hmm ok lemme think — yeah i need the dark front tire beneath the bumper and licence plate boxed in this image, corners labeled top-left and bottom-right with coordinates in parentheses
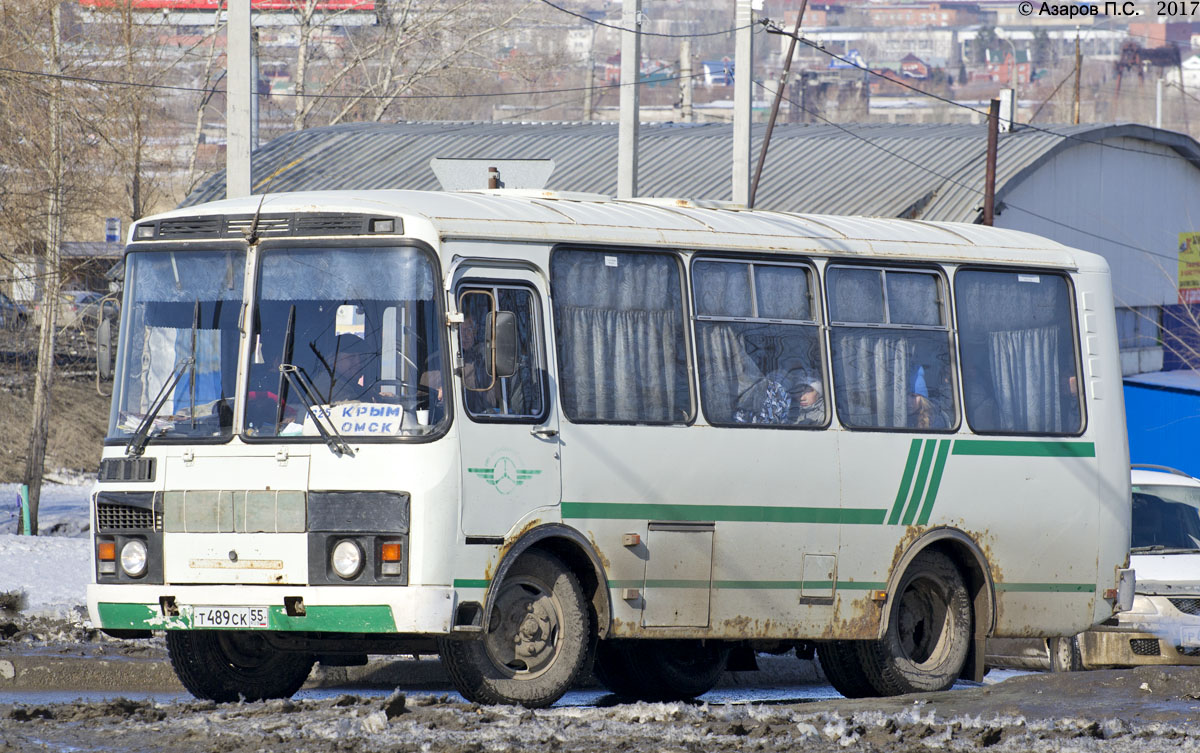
top-left (167, 631), bottom-right (313, 703)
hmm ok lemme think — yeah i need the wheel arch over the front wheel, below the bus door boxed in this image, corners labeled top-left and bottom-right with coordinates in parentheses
top-left (482, 523), bottom-right (612, 638)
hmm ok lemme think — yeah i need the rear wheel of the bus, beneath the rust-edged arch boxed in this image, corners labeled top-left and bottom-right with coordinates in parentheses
top-left (859, 549), bottom-right (971, 695)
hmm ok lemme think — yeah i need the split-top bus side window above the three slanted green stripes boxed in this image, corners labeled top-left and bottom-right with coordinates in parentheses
top-left (826, 266), bottom-right (958, 432)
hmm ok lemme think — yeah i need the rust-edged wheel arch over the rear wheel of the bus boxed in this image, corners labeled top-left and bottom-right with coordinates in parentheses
top-left (878, 526), bottom-right (996, 681)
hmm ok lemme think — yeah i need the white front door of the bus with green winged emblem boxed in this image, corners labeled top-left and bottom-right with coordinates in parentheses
top-left (455, 265), bottom-right (562, 536)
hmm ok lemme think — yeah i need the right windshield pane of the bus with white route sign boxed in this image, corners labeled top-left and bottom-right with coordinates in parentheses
top-left (245, 247), bottom-right (446, 439)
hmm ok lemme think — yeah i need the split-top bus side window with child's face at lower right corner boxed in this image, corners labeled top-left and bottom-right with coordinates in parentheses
top-left (691, 259), bottom-right (826, 427)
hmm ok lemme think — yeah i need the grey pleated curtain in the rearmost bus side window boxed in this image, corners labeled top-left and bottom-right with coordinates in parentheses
top-left (989, 326), bottom-right (1075, 433)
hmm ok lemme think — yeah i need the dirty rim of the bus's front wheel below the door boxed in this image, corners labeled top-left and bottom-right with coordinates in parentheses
top-left (485, 576), bottom-right (563, 679)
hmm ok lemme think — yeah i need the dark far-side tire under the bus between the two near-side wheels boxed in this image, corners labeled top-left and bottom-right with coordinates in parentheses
top-left (595, 640), bottom-right (731, 701)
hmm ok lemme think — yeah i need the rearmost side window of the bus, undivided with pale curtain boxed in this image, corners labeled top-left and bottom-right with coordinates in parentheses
top-left (954, 270), bottom-right (1084, 434)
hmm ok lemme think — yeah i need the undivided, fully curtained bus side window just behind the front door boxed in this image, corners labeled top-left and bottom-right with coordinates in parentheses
top-left (551, 249), bottom-right (692, 423)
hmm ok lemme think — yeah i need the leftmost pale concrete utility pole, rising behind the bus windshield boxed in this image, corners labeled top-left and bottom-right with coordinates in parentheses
top-left (226, 0), bottom-right (251, 199)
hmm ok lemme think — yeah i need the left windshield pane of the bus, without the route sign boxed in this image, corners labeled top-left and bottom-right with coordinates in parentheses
top-left (108, 249), bottom-right (246, 441)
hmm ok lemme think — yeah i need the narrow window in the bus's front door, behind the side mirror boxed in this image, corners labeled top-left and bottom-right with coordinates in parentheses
top-left (456, 285), bottom-right (545, 421)
